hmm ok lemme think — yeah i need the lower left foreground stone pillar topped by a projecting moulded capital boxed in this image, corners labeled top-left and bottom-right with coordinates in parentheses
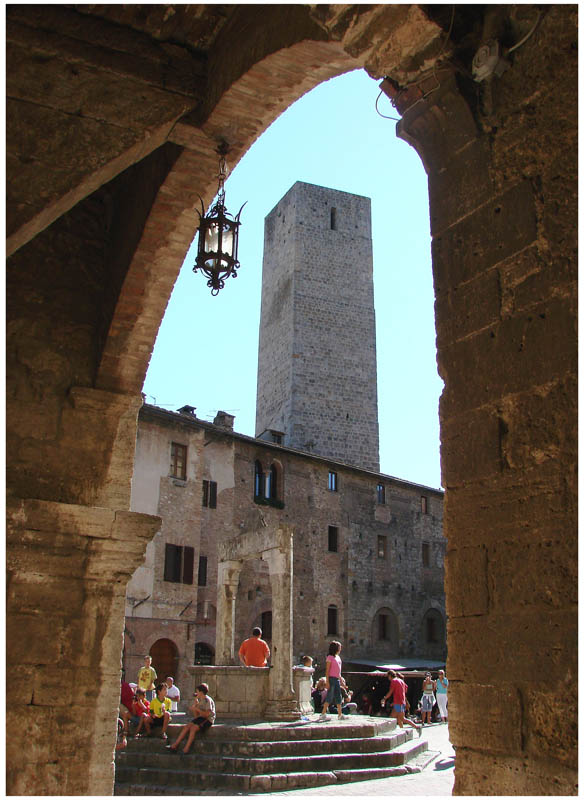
top-left (6, 498), bottom-right (160, 795)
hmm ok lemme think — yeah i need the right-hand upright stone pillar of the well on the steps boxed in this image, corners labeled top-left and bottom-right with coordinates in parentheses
top-left (262, 528), bottom-right (301, 719)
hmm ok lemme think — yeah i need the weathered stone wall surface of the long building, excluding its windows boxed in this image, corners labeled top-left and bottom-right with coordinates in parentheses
top-left (125, 406), bottom-right (446, 676)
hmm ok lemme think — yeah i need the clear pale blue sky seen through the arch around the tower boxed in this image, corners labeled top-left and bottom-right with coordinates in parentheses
top-left (144, 70), bottom-right (442, 487)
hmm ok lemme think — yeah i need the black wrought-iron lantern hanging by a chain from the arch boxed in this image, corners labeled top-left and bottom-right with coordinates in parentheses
top-left (193, 145), bottom-right (245, 296)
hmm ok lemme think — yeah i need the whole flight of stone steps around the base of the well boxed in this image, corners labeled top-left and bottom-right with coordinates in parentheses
top-left (114, 715), bottom-right (428, 796)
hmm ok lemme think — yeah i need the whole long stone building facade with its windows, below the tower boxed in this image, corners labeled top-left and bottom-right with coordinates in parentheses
top-left (124, 405), bottom-right (446, 685)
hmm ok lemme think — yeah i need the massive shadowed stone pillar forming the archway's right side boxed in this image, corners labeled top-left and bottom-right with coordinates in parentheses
top-left (386, 29), bottom-right (578, 795)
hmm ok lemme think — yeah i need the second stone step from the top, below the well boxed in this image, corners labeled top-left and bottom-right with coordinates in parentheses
top-left (123, 730), bottom-right (412, 764)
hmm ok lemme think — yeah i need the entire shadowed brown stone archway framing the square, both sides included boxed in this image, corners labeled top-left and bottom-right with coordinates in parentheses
top-left (6, 5), bottom-right (577, 794)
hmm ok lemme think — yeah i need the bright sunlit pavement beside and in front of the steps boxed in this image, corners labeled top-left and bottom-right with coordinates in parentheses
top-left (253, 724), bottom-right (455, 798)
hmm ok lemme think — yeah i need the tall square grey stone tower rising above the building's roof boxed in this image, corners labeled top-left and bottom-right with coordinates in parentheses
top-left (256, 182), bottom-right (379, 471)
